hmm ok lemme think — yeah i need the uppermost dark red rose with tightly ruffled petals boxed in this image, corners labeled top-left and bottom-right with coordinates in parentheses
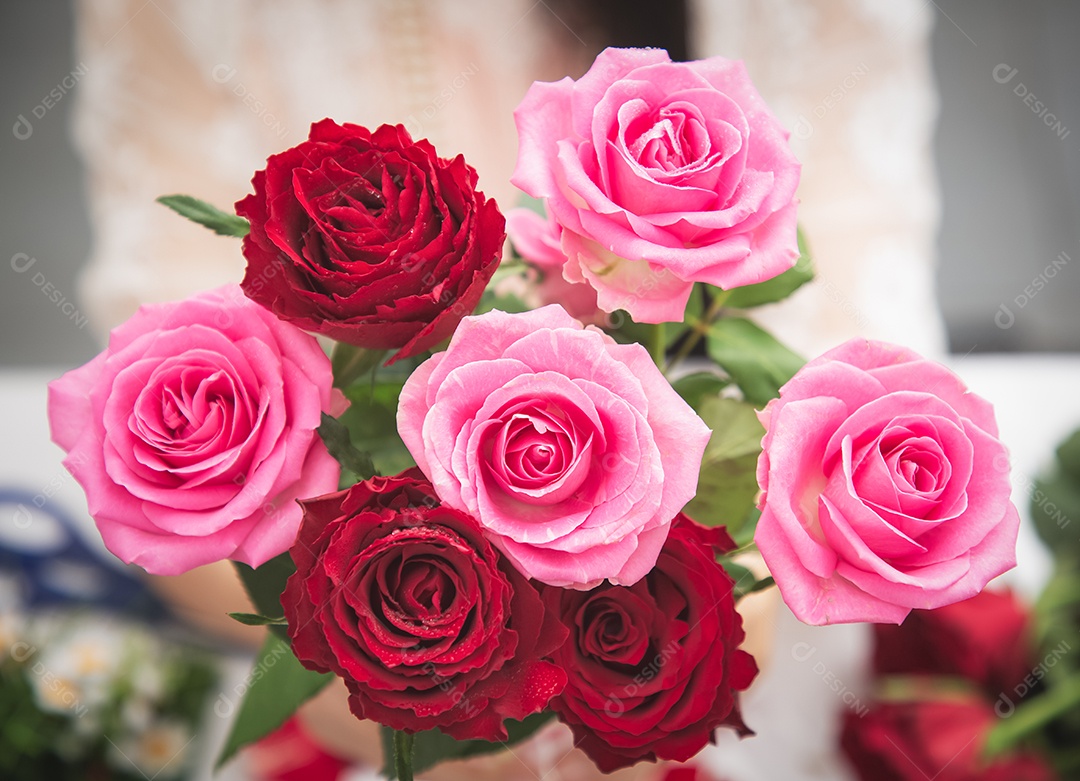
top-left (237, 119), bottom-right (505, 360)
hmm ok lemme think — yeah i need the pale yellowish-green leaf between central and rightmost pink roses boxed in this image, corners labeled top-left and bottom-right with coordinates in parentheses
top-left (686, 398), bottom-right (765, 539)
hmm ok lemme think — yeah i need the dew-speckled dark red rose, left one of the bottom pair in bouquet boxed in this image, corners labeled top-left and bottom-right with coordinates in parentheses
top-left (282, 469), bottom-right (567, 740)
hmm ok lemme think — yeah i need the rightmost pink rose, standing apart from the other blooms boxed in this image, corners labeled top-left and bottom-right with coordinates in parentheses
top-left (754, 339), bottom-right (1020, 624)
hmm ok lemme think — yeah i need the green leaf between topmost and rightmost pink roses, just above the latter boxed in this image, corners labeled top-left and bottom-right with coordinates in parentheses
top-left (705, 318), bottom-right (805, 407)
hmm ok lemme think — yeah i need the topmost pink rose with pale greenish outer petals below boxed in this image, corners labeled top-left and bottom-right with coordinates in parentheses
top-left (512, 49), bottom-right (799, 323)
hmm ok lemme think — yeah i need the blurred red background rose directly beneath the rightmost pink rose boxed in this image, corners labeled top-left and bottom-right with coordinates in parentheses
top-left (874, 591), bottom-right (1035, 699)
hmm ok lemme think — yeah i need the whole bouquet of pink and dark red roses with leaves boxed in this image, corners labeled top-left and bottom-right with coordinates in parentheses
top-left (50, 49), bottom-right (1018, 779)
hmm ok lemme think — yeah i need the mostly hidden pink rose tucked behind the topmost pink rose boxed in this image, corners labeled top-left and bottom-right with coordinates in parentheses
top-left (507, 208), bottom-right (608, 326)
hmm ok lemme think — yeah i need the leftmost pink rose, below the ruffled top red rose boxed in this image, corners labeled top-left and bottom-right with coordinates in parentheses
top-left (49, 285), bottom-right (346, 575)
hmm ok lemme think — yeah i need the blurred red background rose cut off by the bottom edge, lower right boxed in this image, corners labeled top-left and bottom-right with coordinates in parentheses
top-left (840, 698), bottom-right (1056, 781)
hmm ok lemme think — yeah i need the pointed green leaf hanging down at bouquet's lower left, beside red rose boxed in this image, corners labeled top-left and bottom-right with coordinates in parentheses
top-left (214, 634), bottom-right (334, 768)
